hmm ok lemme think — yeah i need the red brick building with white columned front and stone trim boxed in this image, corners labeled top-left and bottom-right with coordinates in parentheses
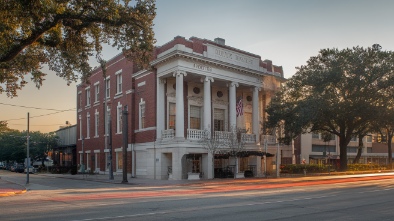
top-left (77, 36), bottom-right (284, 179)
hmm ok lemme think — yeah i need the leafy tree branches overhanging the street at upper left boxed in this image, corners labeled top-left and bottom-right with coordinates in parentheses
top-left (0, 0), bottom-right (156, 97)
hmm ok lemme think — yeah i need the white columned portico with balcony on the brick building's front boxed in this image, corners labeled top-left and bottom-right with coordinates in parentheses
top-left (152, 36), bottom-right (279, 179)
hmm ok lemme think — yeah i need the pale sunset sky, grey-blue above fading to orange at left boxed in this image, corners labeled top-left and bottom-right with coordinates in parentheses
top-left (0, 0), bottom-right (394, 133)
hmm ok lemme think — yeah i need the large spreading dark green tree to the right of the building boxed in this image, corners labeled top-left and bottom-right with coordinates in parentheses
top-left (267, 45), bottom-right (394, 171)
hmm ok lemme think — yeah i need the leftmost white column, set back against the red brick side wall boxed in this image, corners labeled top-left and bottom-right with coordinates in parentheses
top-left (156, 78), bottom-right (166, 140)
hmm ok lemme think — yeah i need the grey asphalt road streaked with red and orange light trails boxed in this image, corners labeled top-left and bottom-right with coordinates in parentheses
top-left (0, 174), bottom-right (394, 221)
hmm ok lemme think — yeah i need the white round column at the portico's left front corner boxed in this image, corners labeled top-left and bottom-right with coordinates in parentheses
top-left (173, 71), bottom-right (186, 139)
